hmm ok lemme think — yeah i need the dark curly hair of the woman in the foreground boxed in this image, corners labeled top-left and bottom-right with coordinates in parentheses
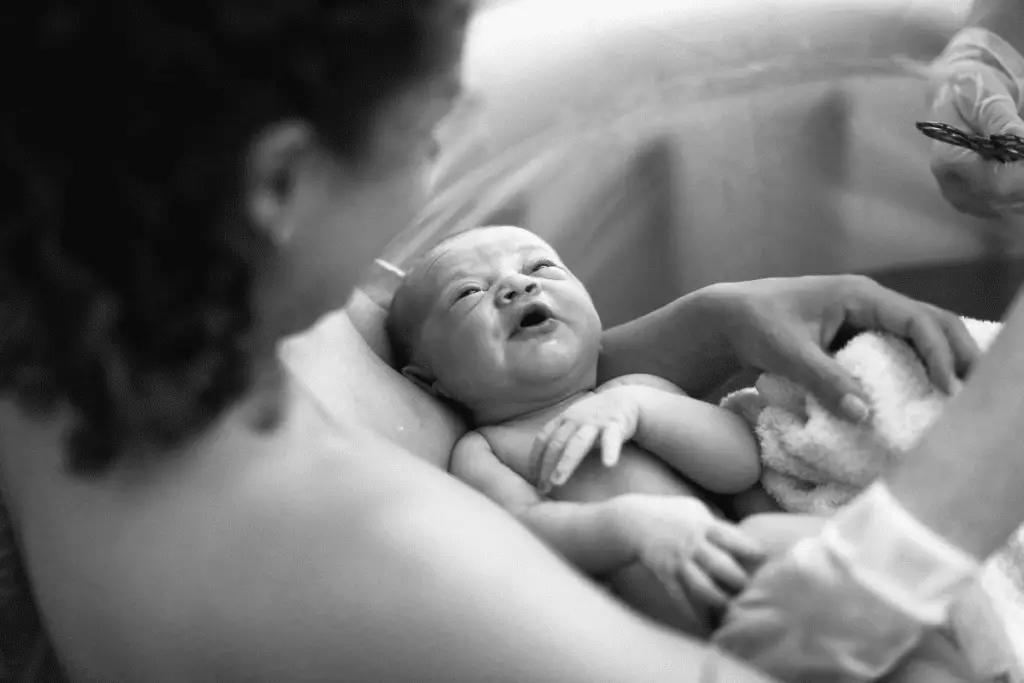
top-left (0, 0), bottom-right (465, 473)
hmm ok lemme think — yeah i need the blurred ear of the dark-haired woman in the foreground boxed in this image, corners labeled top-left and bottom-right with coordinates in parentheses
top-left (245, 121), bottom-right (314, 245)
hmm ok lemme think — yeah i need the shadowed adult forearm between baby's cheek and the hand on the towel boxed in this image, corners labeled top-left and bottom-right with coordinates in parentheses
top-left (598, 286), bottom-right (740, 396)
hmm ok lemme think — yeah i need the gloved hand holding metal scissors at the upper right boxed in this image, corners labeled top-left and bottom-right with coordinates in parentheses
top-left (929, 28), bottom-right (1024, 218)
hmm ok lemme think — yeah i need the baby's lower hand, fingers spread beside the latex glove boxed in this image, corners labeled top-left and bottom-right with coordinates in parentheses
top-left (615, 495), bottom-right (766, 612)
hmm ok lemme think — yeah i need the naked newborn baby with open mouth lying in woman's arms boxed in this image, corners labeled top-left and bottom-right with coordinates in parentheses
top-left (387, 227), bottom-right (801, 635)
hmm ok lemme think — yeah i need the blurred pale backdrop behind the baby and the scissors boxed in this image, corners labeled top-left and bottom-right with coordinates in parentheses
top-left (376, 0), bottom-right (1024, 326)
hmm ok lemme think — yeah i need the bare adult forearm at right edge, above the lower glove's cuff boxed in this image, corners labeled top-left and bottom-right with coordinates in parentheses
top-left (887, 286), bottom-right (1024, 558)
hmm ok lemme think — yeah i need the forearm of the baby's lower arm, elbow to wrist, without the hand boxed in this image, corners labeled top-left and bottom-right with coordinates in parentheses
top-left (516, 501), bottom-right (637, 577)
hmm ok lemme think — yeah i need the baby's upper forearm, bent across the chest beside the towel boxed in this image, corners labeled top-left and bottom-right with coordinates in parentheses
top-left (628, 387), bottom-right (761, 494)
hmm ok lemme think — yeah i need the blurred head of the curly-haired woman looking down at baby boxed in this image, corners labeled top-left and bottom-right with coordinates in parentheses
top-left (0, 0), bottom-right (468, 470)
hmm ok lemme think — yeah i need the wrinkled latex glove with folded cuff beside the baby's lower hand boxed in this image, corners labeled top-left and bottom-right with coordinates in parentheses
top-left (714, 483), bottom-right (980, 683)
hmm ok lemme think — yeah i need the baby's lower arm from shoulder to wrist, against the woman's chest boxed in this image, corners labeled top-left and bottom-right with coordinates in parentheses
top-left (451, 432), bottom-right (637, 575)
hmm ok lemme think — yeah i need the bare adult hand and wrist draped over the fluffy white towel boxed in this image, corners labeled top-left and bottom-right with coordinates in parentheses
top-left (599, 275), bottom-right (980, 421)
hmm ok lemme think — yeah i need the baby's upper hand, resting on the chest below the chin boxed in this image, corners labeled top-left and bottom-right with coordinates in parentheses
top-left (529, 386), bottom-right (640, 494)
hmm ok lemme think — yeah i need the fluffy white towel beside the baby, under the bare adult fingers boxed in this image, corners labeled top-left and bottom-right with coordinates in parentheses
top-left (722, 318), bottom-right (1024, 683)
